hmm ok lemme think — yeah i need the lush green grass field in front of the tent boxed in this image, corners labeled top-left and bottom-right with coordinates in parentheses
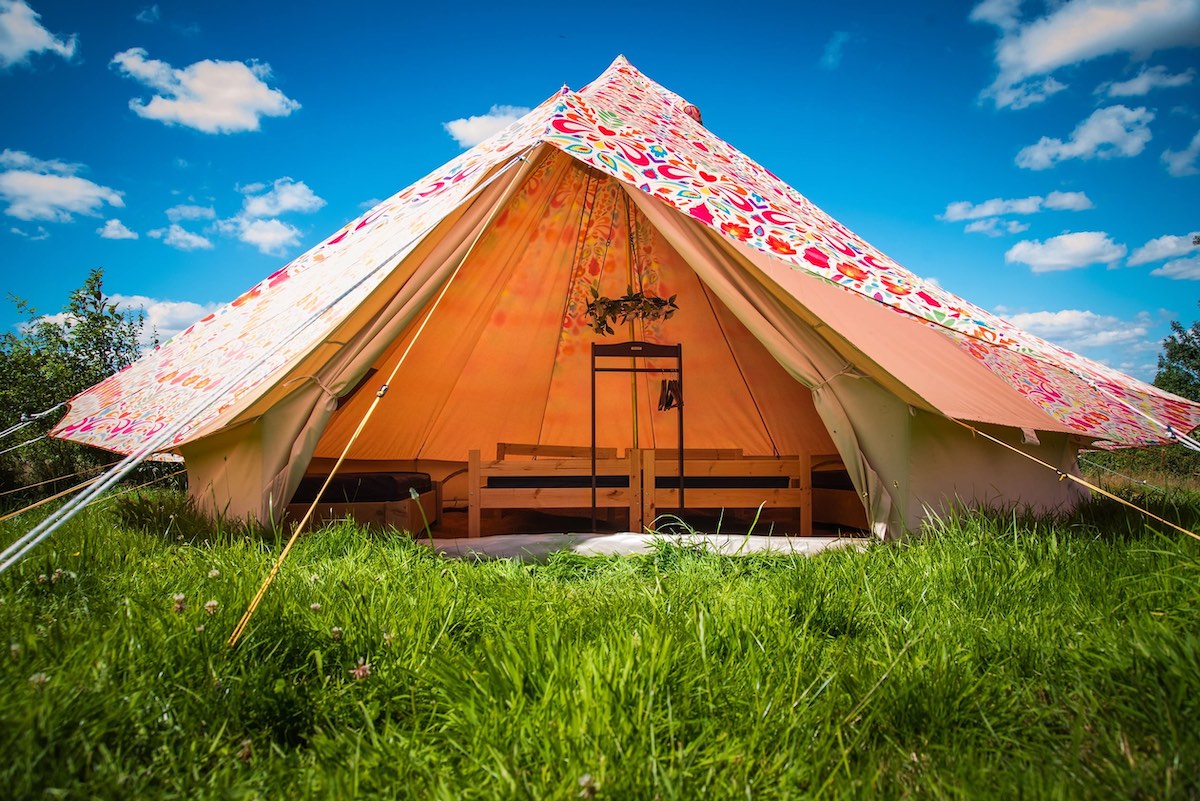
top-left (0, 491), bottom-right (1200, 799)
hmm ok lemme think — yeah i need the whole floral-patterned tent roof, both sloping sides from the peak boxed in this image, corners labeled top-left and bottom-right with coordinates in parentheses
top-left (54, 58), bottom-right (1200, 453)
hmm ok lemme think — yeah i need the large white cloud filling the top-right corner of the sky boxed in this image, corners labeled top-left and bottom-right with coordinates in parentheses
top-left (971, 0), bottom-right (1200, 108)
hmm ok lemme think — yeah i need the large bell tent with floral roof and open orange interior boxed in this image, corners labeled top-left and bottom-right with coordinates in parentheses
top-left (54, 58), bottom-right (1200, 536)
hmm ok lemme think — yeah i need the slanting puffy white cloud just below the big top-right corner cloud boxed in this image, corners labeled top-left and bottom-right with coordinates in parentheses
top-left (1016, 105), bottom-right (1152, 170)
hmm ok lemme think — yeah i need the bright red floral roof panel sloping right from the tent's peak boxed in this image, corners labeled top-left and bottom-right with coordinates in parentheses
top-left (546, 59), bottom-right (1200, 445)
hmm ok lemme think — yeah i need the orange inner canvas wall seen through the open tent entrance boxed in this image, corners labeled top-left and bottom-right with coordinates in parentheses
top-left (294, 150), bottom-right (836, 532)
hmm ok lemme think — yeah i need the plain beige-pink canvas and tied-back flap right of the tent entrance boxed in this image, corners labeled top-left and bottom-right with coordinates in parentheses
top-left (634, 185), bottom-right (1099, 536)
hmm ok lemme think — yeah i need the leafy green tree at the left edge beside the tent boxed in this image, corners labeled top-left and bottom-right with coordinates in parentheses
top-left (0, 267), bottom-right (145, 489)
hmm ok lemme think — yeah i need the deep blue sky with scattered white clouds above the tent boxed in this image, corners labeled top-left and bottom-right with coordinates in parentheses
top-left (0, 0), bottom-right (1200, 380)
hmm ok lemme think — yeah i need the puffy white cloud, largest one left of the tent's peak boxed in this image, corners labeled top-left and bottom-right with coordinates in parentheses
top-left (112, 47), bottom-right (300, 133)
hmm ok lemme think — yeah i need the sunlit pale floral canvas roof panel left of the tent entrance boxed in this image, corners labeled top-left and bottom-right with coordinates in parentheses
top-left (46, 95), bottom-right (553, 453)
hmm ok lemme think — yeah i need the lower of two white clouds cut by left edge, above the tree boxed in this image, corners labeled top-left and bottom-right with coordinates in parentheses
top-left (0, 150), bottom-right (125, 223)
